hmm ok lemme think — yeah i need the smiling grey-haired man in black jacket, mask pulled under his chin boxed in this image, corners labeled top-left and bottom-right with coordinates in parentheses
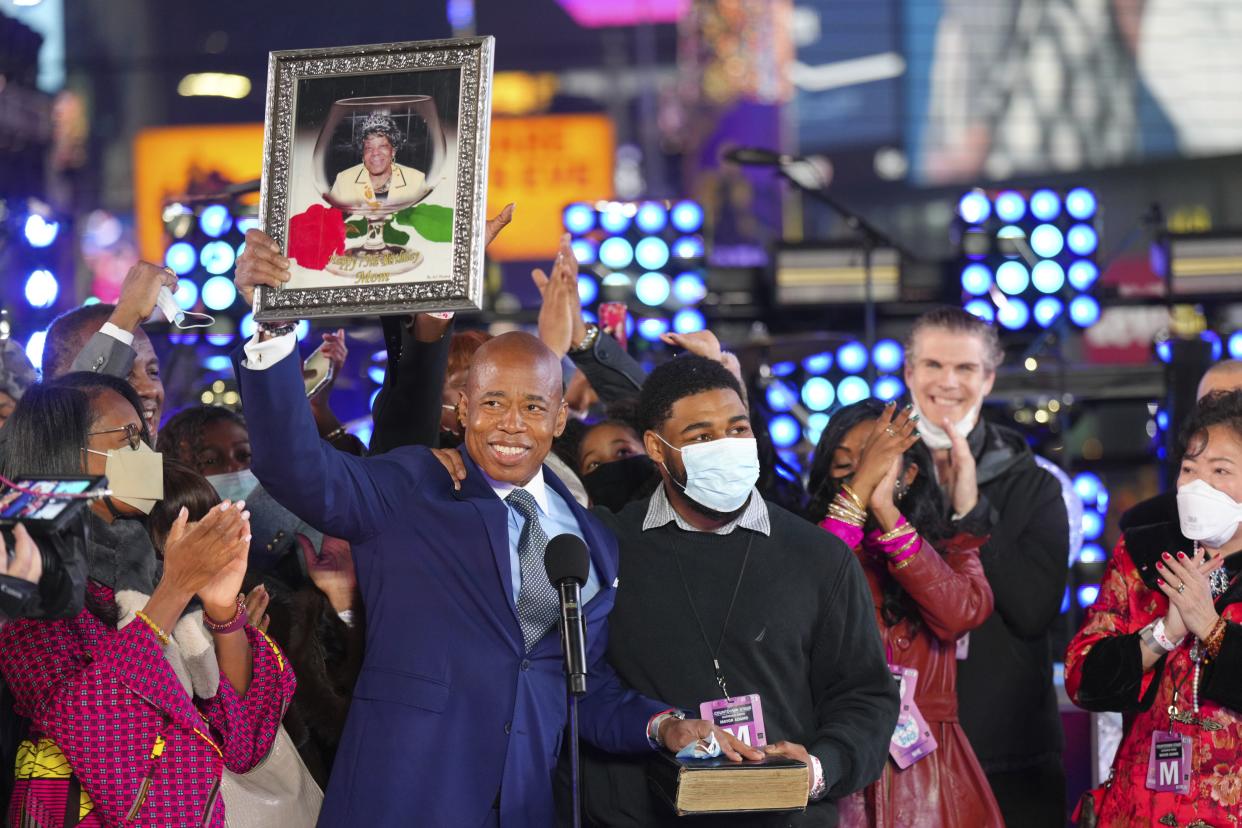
top-left (905, 308), bottom-right (1069, 828)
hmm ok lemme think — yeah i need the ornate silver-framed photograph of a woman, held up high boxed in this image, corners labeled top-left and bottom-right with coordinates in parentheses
top-left (255, 37), bottom-right (494, 320)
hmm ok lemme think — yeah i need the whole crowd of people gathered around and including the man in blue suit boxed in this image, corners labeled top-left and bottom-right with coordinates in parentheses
top-left (0, 210), bottom-right (1242, 828)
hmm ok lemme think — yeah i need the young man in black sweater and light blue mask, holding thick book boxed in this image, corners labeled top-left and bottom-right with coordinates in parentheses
top-left (582, 355), bottom-right (898, 827)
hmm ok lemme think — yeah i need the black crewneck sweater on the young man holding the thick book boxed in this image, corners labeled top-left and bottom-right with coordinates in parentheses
top-left (582, 500), bottom-right (898, 827)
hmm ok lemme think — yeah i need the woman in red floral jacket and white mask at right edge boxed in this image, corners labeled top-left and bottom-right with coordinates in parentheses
top-left (1066, 392), bottom-right (1242, 828)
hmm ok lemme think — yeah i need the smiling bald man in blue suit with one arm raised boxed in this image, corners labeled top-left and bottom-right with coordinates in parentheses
top-left (237, 326), bottom-right (761, 827)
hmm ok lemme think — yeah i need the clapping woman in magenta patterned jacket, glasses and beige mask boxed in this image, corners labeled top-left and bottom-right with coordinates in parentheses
top-left (0, 375), bottom-right (294, 828)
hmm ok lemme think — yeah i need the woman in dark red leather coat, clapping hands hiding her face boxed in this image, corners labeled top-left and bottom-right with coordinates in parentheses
top-left (809, 400), bottom-right (1004, 828)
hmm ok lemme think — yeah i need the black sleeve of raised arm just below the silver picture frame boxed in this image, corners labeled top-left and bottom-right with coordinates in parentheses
top-left (371, 317), bottom-right (453, 454)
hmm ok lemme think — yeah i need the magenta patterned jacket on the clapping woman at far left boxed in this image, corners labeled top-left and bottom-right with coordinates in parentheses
top-left (0, 583), bottom-right (296, 828)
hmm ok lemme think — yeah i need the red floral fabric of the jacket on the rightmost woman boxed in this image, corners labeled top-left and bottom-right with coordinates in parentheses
top-left (1066, 539), bottom-right (1242, 828)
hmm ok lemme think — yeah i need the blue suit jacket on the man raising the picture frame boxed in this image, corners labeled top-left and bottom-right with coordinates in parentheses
top-left (236, 354), bottom-right (667, 828)
